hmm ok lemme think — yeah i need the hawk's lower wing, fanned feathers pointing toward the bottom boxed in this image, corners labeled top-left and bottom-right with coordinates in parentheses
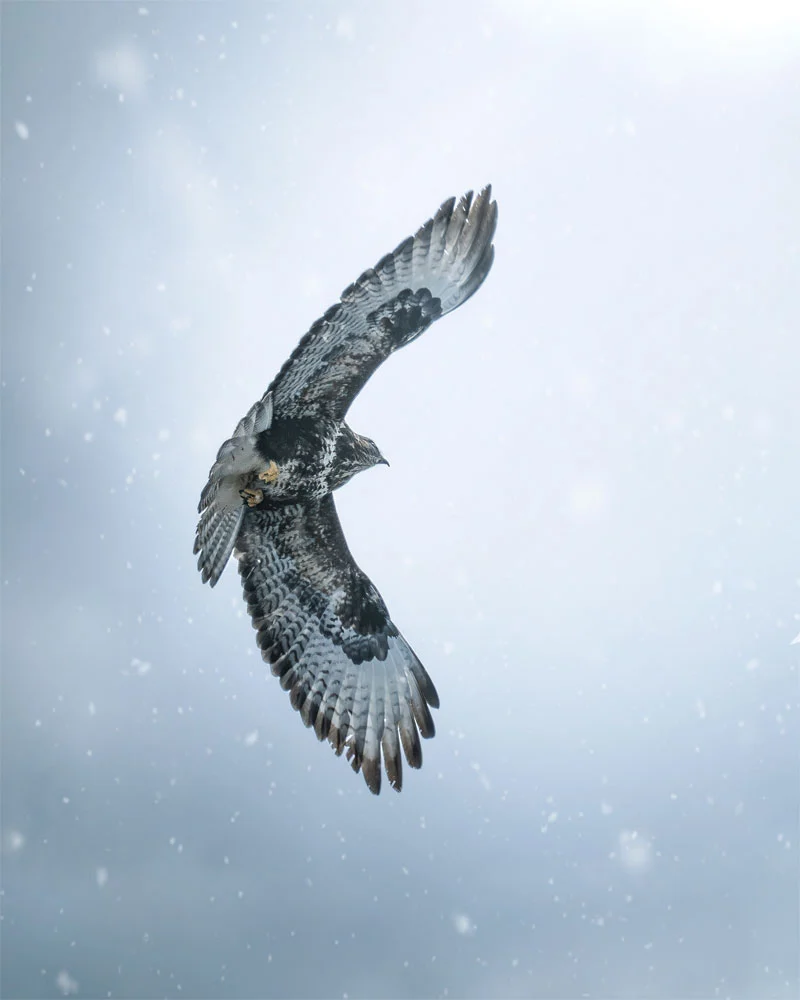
top-left (234, 494), bottom-right (439, 794)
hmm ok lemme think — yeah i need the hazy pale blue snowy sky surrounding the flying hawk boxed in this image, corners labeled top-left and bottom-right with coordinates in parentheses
top-left (2, 0), bottom-right (800, 1000)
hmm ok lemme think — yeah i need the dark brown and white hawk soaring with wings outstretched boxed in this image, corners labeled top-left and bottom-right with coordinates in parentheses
top-left (194, 186), bottom-right (497, 794)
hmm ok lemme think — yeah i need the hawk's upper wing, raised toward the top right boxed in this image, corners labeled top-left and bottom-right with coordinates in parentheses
top-left (270, 185), bottom-right (497, 419)
